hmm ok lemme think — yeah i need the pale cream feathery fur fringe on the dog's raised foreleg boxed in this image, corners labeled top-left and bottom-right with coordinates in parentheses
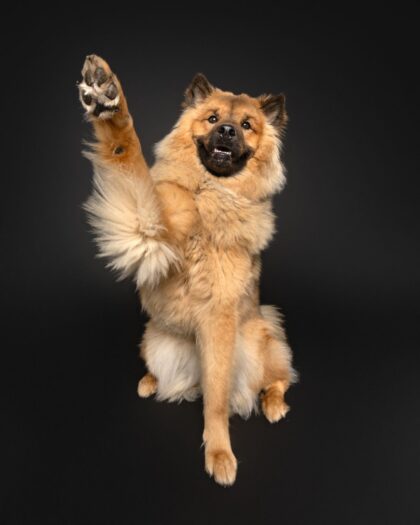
top-left (84, 161), bottom-right (179, 287)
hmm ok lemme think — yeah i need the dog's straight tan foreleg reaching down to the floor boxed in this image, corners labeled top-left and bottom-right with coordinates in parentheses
top-left (199, 309), bottom-right (237, 485)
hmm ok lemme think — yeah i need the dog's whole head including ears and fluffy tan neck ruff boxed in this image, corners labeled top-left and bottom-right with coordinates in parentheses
top-left (156, 74), bottom-right (287, 199)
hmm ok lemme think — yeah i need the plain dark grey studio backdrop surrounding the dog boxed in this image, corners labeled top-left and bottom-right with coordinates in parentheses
top-left (0, 2), bottom-right (420, 525)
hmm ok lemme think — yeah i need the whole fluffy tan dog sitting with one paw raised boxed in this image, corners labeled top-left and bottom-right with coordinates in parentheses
top-left (79, 55), bottom-right (296, 485)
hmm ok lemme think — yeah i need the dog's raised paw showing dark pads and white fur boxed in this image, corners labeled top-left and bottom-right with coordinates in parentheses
top-left (78, 55), bottom-right (120, 120)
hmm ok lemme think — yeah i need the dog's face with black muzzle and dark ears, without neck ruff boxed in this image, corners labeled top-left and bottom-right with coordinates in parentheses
top-left (184, 74), bottom-right (287, 177)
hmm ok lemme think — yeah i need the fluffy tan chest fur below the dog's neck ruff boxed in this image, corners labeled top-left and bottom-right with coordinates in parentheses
top-left (184, 180), bottom-right (274, 307)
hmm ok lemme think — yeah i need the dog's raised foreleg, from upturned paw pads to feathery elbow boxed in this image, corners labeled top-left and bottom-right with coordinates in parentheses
top-left (79, 55), bottom-right (179, 287)
